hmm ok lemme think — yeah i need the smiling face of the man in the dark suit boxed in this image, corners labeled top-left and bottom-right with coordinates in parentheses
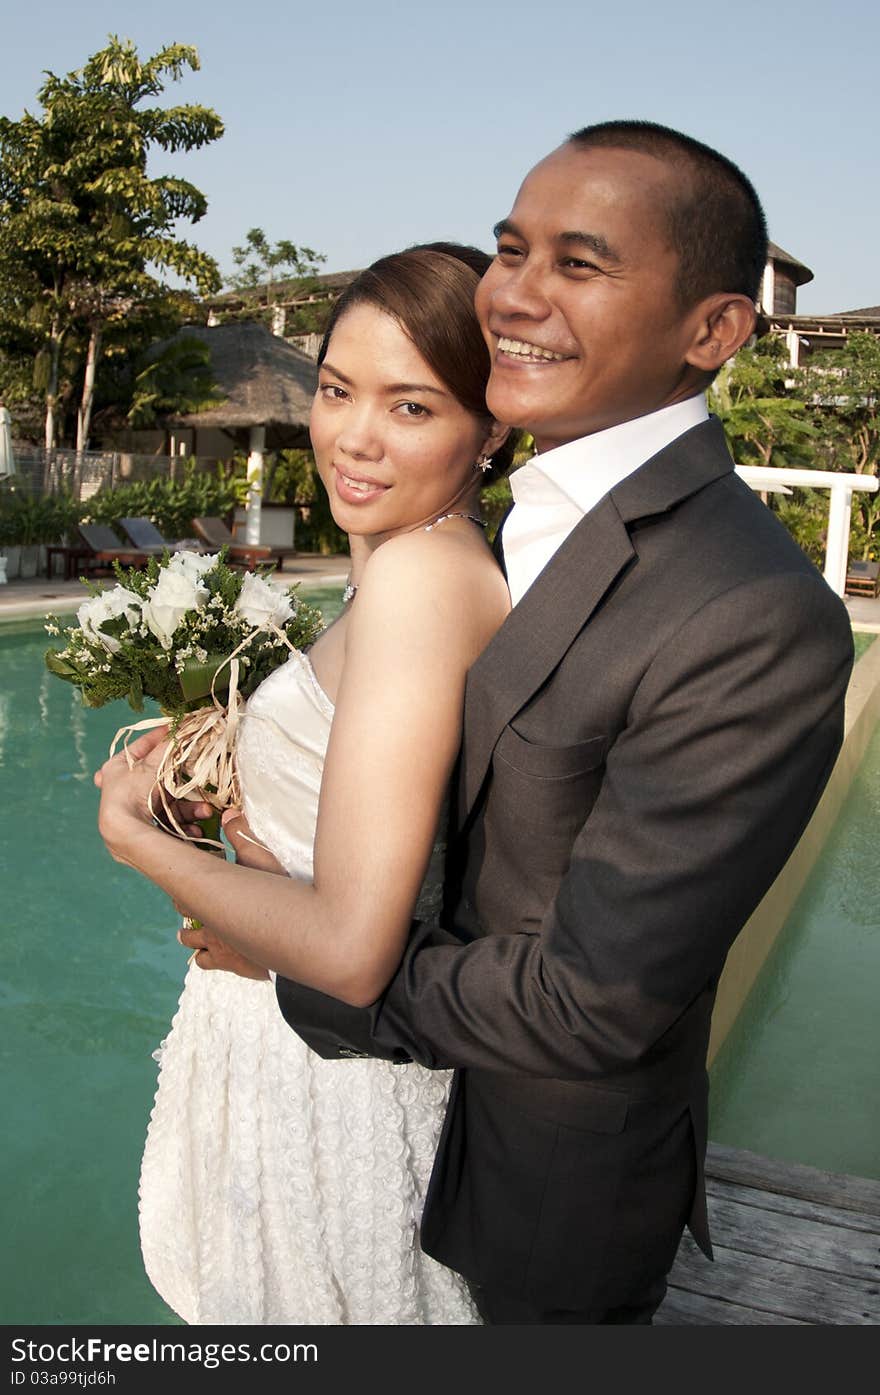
top-left (477, 144), bottom-right (700, 451)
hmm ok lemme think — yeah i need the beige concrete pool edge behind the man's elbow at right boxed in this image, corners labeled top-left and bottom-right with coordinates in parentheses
top-left (708, 626), bottom-right (880, 1066)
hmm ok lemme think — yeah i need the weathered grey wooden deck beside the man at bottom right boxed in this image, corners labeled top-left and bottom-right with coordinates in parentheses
top-left (654, 1144), bottom-right (880, 1327)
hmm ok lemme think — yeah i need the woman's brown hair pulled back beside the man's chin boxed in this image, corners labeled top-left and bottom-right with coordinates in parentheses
top-left (318, 243), bottom-right (515, 483)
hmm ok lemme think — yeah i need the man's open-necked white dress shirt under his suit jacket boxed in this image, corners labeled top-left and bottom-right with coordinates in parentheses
top-left (501, 393), bottom-right (708, 605)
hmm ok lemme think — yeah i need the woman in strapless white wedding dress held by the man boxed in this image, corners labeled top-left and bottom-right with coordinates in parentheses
top-left (98, 248), bottom-right (510, 1324)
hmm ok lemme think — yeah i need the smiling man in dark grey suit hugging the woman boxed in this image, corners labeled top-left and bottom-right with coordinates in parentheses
top-left (203, 123), bottom-right (852, 1324)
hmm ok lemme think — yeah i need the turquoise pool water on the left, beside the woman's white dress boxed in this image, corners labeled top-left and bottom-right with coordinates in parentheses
top-left (0, 587), bottom-right (340, 1324)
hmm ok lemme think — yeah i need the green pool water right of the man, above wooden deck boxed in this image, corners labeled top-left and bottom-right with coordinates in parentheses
top-left (710, 730), bottom-right (880, 1179)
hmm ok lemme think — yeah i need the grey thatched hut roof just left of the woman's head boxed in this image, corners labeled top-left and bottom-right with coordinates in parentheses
top-left (169, 321), bottom-right (318, 451)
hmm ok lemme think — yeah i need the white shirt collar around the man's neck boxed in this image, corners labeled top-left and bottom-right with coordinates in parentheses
top-left (510, 392), bottom-right (708, 513)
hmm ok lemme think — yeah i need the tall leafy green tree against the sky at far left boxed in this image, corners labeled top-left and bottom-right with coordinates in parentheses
top-left (0, 35), bottom-right (223, 449)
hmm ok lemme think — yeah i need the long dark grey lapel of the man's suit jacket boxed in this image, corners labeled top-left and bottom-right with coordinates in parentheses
top-left (459, 417), bottom-right (732, 822)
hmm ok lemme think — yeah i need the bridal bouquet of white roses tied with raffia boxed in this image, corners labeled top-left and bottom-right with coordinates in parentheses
top-left (46, 552), bottom-right (322, 841)
